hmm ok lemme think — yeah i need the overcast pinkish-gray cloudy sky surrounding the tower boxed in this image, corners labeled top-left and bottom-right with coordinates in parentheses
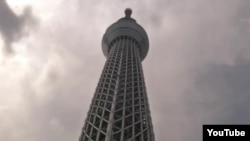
top-left (0, 0), bottom-right (250, 141)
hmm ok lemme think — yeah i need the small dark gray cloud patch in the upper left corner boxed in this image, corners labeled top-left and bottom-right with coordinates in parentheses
top-left (0, 0), bottom-right (37, 52)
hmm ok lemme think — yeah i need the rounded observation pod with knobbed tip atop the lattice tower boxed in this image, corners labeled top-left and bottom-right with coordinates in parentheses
top-left (102, 8), bottom-right (149, 60)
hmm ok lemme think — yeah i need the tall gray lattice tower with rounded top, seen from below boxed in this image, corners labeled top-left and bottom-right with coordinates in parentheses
top-left (79, 8), bottom-right (154, 141)
